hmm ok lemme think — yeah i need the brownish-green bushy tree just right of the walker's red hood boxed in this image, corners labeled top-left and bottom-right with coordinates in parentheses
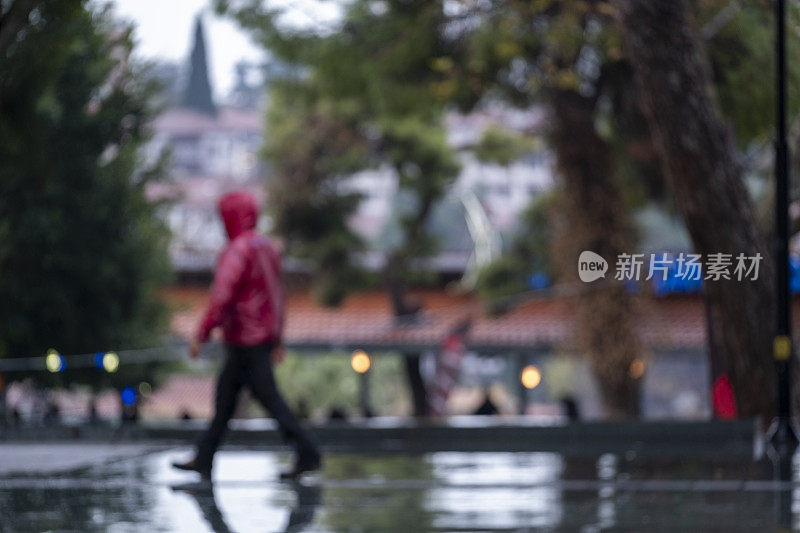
top-left (265, 84), bottom-right (366, 305)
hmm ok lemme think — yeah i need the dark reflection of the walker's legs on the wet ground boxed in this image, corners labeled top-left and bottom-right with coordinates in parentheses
top-left (175, 482), bottom-right (322, 533)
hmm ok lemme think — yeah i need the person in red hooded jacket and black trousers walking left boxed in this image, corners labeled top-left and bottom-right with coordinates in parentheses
top-left (173, 192), bottom-right (320, 480)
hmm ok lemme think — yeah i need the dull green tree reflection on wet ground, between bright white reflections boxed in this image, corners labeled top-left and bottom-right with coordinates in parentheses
top-left (322, 455), bottom-right (433, 532)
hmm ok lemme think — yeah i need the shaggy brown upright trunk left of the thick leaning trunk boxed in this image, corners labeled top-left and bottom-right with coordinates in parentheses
top-left (551, 90), bottom-right (640, 419)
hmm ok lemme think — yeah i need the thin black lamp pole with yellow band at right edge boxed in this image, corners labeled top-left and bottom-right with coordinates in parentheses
top-left (770, 0), bottom-right (797, 447)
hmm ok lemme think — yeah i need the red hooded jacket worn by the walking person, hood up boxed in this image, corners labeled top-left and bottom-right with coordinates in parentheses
top-left (197, 192), bottom-right (284, 346)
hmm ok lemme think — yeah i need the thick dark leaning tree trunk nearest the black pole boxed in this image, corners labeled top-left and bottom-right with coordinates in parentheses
top-left (615, 0), bottom-right (775, 421)
